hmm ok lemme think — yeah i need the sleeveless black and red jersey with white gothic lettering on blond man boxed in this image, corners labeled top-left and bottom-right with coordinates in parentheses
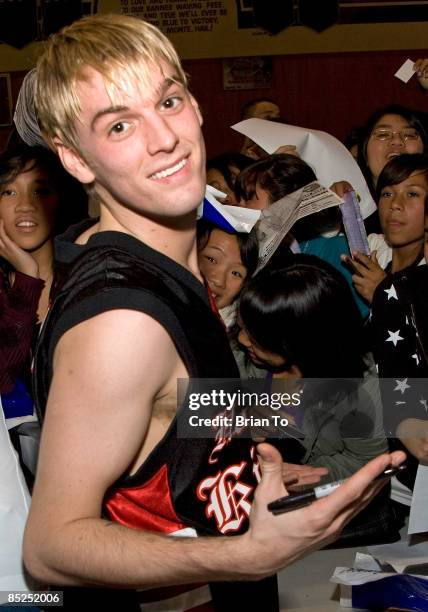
top-left (34, 232), bottom-right (277, 611)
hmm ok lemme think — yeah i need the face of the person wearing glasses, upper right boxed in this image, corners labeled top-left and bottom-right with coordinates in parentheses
top-left (367, 115), bottom-right (424, 184)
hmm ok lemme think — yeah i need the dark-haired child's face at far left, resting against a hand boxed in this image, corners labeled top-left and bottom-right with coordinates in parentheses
top-left (0, 162), bottom-right (58, 251)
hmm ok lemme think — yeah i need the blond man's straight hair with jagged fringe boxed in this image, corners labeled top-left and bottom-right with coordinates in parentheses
top-left (35, 14), bottom-right (187, 151)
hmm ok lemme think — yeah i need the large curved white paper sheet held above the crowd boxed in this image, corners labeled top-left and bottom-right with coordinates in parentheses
top-left (232, 119), bottom-right (376, 219)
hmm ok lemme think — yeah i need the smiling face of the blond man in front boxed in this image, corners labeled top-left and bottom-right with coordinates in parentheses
top-left (61, 64), bottom-right (205, 219)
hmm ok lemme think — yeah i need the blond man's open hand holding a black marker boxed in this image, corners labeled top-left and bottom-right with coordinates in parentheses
top-left (242, 444), bottom-right (405, 576)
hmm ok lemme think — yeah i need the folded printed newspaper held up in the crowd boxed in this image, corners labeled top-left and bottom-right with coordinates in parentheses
top-left (256, 181), bottom-right (343, 272)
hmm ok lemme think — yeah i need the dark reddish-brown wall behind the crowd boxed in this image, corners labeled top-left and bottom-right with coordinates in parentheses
top-left (0, 49), bottom-right (428, 157)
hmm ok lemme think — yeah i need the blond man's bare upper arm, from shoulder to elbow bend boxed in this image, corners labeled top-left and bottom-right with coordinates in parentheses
top-left (31, 310), bottom-right (181, 513)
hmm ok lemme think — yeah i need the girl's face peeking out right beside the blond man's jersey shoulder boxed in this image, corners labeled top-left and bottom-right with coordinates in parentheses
top-left (198, 229), bottom-right (247, 308)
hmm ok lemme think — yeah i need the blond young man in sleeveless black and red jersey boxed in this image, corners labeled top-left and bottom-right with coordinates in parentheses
top-left (24, 15), bottom-right (403, 610)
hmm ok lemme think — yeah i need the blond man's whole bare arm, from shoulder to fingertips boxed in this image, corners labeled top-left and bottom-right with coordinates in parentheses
top-left (24, 311), bottom-right (403, 588)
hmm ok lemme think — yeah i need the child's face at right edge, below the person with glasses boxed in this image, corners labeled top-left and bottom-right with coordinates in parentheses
top-left (379, 171), bottom-right (428, 247)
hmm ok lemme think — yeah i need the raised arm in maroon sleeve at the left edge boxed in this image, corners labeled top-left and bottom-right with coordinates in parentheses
top-left (0, 220), bottom-right (44, 393)
